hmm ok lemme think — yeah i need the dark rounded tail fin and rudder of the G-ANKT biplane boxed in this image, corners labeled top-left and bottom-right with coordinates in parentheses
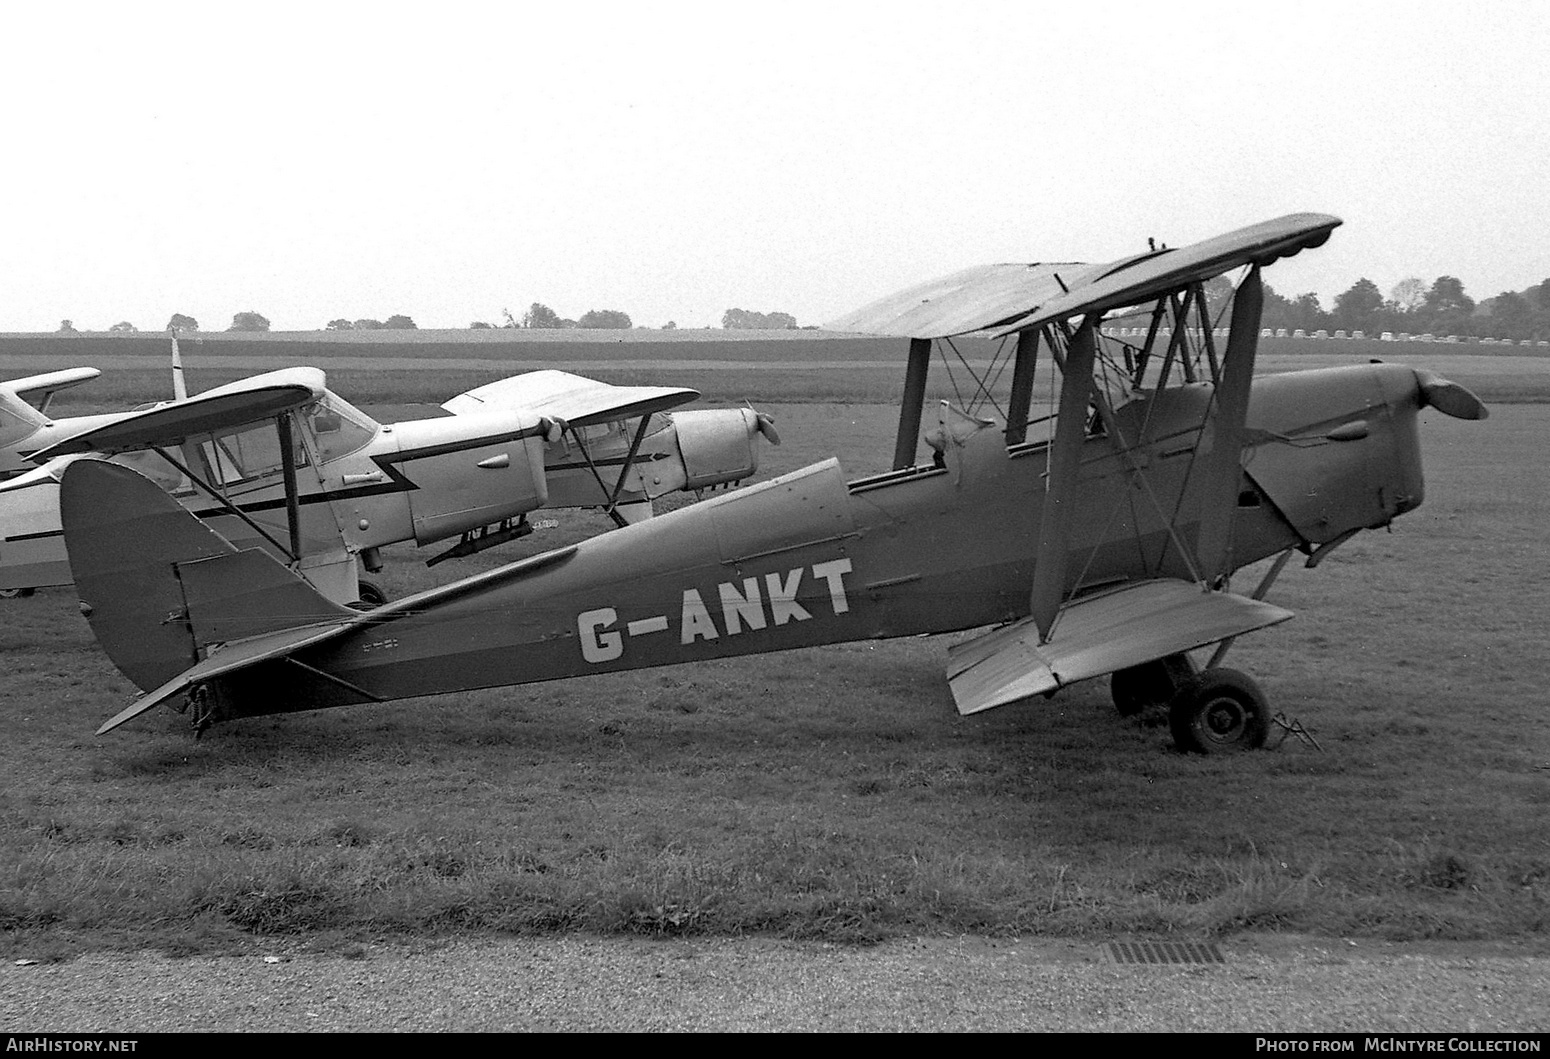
top-left (59, 459), bottom-right (355, 690)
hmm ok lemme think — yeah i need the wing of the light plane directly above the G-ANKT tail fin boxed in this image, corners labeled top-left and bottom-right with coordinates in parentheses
top-left (28, 367), bottom-right (324, 464)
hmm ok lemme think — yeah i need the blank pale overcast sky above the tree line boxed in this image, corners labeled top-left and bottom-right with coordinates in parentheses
top-left (0, 0), bottom-right (1550, 330)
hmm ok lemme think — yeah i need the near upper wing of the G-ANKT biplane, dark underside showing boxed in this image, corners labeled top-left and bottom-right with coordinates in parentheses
top-left (997, 214), bottom-right (1342, 338)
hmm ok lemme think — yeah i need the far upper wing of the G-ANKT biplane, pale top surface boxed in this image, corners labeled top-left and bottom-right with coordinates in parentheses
top-left (823, 262), bottom-right (1096, 338)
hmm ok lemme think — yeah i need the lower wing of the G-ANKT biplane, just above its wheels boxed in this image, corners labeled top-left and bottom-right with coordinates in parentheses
top-left (947, 580), bottom-right (1291, 713)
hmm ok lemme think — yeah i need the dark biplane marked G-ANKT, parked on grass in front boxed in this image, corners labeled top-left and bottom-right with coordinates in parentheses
top-left (60, 214), bottom-right (1486, 752)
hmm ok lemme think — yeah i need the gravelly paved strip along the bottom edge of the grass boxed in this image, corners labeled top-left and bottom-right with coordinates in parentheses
top-left (0, 937), bottom-right (1550, 1034)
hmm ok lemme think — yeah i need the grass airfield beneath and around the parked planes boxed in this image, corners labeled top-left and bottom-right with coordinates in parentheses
top-left (0, 341), bottom-right (1550, 958)
